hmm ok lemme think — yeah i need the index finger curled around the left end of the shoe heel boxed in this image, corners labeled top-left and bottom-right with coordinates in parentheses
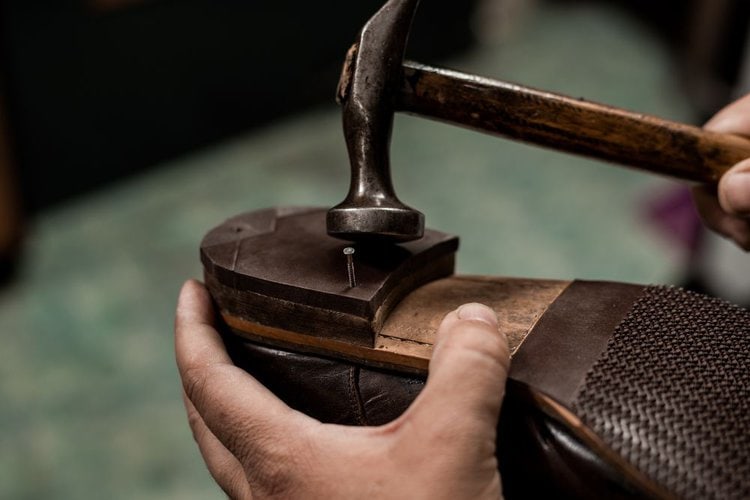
top-left (175, 281), bottom-right (317, 490)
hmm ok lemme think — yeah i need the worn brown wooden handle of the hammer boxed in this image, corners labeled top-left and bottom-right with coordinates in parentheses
top-left (396, 62), bottom-right (750, 183)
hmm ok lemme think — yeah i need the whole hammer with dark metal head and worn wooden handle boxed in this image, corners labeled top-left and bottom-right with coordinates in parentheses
top-left (326, 0), bottom-right (750, 242)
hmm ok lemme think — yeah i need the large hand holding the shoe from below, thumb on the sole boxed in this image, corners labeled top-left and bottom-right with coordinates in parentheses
top-left (175, 281), bottom-right (509, 499)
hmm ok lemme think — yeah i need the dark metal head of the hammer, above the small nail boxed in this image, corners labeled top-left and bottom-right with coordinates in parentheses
top-left (326, 0), bottom-right (424, 242)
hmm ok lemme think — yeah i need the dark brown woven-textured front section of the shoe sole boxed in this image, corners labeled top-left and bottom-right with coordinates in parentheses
top-left (573, 287), bottom-right (750, 498)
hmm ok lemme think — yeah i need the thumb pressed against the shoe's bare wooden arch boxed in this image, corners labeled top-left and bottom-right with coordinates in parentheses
top-left (409, 304), bottom-right (510, 444)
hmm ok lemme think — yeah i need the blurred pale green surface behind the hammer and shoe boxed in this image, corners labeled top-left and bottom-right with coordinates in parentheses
top-left (0, 1), bottom-right (748, 499)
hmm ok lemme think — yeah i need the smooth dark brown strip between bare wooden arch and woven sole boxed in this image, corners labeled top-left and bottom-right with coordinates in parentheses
top-left (509, 281), bottom-right (645, 406)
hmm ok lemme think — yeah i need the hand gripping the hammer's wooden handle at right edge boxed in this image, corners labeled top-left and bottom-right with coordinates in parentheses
top-left (693, 95), bottom-right (750, 250)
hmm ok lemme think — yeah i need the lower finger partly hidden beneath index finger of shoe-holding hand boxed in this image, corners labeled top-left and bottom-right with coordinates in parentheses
top-left (182, 392), bottom-right (252, 498)
